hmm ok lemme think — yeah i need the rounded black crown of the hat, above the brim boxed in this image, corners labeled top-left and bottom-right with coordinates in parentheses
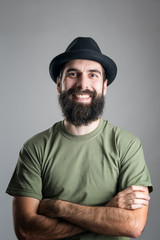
top-left (66, 37), bottom-right (101, 53)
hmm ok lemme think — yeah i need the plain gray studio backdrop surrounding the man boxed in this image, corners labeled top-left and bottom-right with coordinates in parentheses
top-left (0, 0), bottom-right (160, 240)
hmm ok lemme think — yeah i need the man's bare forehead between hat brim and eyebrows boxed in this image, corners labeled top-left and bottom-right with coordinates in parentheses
top-left (64, 59), bottom-right (103, 72)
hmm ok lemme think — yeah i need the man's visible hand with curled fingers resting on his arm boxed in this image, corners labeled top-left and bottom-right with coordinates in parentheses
top-left (106, 186), bottom-right (150, 209)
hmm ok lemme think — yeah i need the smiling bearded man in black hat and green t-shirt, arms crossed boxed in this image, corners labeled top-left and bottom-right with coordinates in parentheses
top-left (7, 37), bottom-right (152, 240)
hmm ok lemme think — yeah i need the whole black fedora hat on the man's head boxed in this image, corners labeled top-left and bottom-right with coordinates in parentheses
top-left (49, 37), bottom-right (117, 85)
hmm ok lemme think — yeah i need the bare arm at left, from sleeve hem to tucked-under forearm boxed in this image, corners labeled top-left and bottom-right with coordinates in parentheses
top-left (13, 196), bottom-right (84, 240)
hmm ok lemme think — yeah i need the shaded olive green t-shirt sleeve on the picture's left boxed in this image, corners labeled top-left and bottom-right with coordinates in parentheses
top-left (6, 145), bottom-right (42, 200)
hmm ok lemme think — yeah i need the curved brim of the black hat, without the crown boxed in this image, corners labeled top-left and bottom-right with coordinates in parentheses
top-left (49, 49), bottom-right (117, 85)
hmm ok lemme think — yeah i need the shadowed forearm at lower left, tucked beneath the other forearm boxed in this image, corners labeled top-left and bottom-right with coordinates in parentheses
top-left (17, 215), bottom-right (84, 240)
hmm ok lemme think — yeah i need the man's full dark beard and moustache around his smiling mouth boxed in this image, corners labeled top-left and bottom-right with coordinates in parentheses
top-left (59, 88), bottom-right (105, 126)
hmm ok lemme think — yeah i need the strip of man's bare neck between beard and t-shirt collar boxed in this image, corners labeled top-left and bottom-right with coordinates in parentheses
top-left (64, 118), bottom-right (100, 135)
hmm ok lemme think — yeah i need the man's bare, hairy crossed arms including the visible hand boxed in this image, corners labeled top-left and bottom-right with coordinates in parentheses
top-left (13, 186), bottom-right (149, 240)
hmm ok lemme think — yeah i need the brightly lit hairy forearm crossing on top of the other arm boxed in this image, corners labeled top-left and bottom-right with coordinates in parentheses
top-left (42, 200), bottom-right (148, 237)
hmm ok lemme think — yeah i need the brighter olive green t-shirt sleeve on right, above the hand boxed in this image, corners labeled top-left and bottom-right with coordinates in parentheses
top-left (119, 138), bottom-right (153, 192)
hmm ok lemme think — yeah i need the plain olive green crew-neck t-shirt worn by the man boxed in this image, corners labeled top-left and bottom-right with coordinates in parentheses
top-left (6, 119), bottom-right (152, 240)
